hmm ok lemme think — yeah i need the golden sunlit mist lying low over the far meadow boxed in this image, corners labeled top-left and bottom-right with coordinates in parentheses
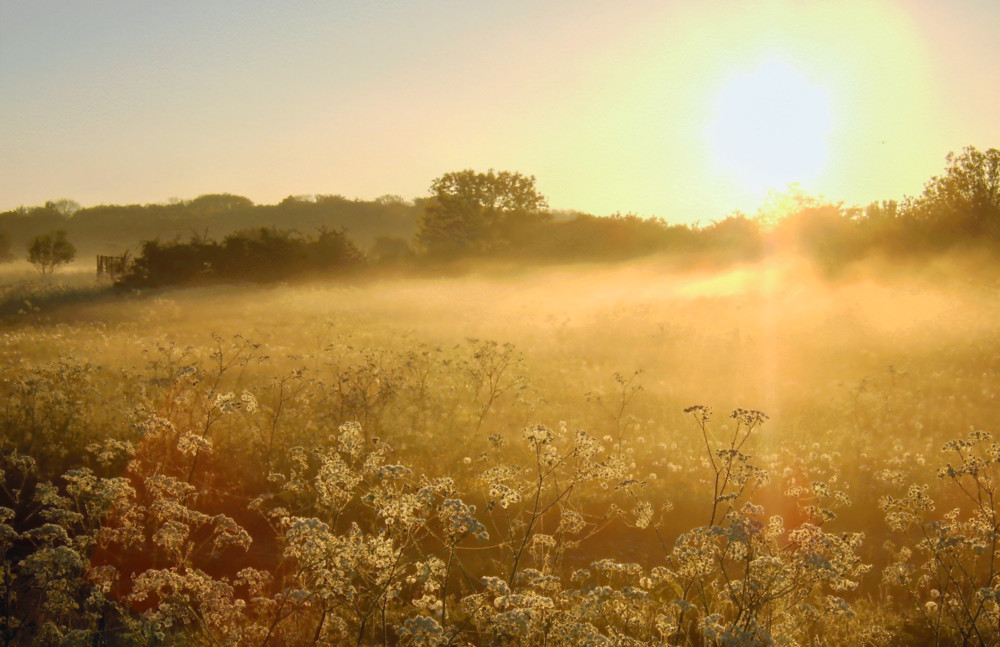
top-left (11, 248), bottom-right (1000, 434)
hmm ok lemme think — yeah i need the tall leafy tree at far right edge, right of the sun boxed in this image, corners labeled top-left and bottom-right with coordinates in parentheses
top-left (904, 146), bottom-right (1000, 236)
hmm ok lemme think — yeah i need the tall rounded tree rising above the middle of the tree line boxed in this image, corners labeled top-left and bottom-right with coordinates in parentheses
top-left (417, 169), bottom-right (548, 256)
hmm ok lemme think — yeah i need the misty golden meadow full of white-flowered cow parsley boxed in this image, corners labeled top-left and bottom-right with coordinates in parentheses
top-left (0, 255), bottom-right (1000, 645)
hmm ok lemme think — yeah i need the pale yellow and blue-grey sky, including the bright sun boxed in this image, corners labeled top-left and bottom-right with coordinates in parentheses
top-left (0, 0), bottom-right (1000, 224)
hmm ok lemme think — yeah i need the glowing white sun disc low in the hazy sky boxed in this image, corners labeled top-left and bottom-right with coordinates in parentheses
top-left (708, 61), bottom-right (831, 193)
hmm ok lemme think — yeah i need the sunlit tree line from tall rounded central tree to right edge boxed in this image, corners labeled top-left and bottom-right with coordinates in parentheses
top-left (417, 147), bottom-right (1000, 269)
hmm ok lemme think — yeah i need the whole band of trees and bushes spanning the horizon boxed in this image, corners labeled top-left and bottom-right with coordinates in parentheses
top-left (0, 147), bottom-right (1000, 287)
